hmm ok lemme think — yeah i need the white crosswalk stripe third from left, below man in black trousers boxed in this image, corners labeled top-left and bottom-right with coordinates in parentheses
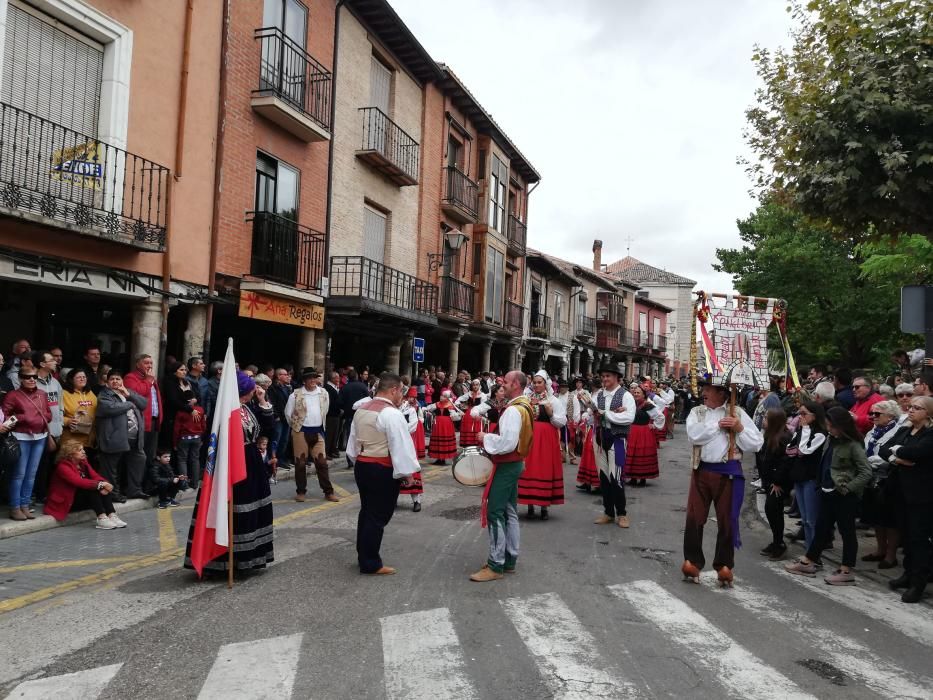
top-left (380, 608), bottom-right (477, 700)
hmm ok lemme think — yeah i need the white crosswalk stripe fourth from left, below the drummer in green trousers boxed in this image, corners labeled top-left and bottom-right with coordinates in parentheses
top-left (502, 593), bottom-right (639, 700)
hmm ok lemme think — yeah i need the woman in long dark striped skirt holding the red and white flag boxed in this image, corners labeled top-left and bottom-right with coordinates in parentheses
top-left (184, 372), bottom-right (275, 574)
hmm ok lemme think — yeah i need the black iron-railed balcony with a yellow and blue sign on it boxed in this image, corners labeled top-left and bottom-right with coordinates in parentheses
top-left (0, 104), bottom-right (169, 251)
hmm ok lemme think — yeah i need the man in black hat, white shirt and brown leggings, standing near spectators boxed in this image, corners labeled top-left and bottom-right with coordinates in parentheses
top-left (285, 367), bottom-right (340, 503)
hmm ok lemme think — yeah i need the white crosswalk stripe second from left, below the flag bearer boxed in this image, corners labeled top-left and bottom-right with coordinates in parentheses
top-left (198, 634), bottom-right (304, 700)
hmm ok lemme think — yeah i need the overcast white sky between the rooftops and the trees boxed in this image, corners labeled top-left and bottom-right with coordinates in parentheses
top-left (390, 0), bottom-right (790, 291)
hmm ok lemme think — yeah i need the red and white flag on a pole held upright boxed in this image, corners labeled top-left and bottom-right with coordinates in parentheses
top-left (191, 338), bottom-right (246, 576)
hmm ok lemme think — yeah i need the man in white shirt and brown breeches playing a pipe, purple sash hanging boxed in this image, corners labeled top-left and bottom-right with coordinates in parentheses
top-left (681, 382), bottom-right (764, 585)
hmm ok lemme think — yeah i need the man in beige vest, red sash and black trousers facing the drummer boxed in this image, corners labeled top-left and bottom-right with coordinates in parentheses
top-left (347, 372), bottom-right (421, 575)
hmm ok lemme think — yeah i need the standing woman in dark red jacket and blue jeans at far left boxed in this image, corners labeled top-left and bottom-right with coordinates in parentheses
top-left (2, 367), bottom-right (52, 520)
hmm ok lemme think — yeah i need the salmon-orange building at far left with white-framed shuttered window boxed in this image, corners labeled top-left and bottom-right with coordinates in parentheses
top-left (0, 0), bottom-right (221, 367)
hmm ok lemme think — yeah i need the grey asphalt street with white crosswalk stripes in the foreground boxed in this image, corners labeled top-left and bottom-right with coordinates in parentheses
top-left (0, 434), bottom-right (933, 700)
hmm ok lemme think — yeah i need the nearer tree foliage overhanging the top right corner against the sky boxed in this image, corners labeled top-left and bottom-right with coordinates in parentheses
top-left (745, 0), bottom-right (933, 240)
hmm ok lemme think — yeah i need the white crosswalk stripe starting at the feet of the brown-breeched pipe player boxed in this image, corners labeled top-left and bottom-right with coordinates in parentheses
top-left (701, 575), bottom-right (933, 700)
